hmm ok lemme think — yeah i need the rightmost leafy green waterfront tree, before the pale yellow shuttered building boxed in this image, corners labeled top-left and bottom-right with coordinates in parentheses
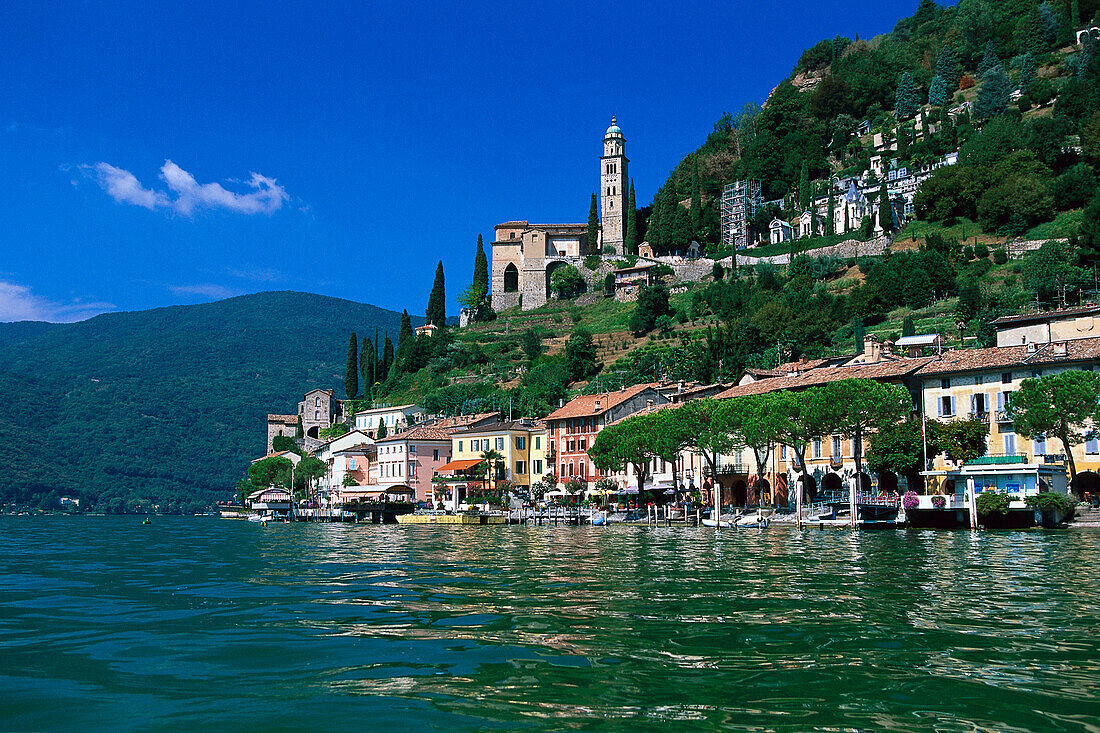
top-left (1008, 370), bottom-right (1100, 493)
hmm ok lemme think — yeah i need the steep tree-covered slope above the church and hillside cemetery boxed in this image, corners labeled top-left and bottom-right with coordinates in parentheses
top-left (636, 0), bottom-right (1100, 252)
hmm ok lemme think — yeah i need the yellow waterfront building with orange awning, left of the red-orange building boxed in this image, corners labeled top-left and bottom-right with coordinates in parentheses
top-left (451, 418), bottom-right (550, 488)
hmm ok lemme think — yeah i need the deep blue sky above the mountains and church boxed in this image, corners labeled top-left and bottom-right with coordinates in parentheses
top-left (0, 0), bottom-right (916, 321)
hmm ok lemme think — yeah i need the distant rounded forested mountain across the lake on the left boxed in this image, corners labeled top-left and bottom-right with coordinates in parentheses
top-left (0, 292), bottom-right (413, 511)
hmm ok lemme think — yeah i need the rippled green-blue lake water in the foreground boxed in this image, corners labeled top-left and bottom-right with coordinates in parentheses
top-left (0, 516), bottom-right (1100, 731)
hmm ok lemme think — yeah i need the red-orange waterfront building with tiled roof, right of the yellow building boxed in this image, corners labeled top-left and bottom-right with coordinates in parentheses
top-left (546, 383), bottom-right (669, 486)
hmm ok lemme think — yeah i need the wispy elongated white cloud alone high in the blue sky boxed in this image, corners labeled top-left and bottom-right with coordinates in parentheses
top-left (84, 161), bottom-right (290, 216)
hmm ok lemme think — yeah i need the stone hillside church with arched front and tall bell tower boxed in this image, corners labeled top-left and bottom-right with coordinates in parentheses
top-left (491, 118), bottom-right (630, 310)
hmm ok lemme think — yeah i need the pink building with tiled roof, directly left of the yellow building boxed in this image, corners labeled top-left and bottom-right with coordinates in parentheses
top-left (371, 425), bottom-right (451, 502)
